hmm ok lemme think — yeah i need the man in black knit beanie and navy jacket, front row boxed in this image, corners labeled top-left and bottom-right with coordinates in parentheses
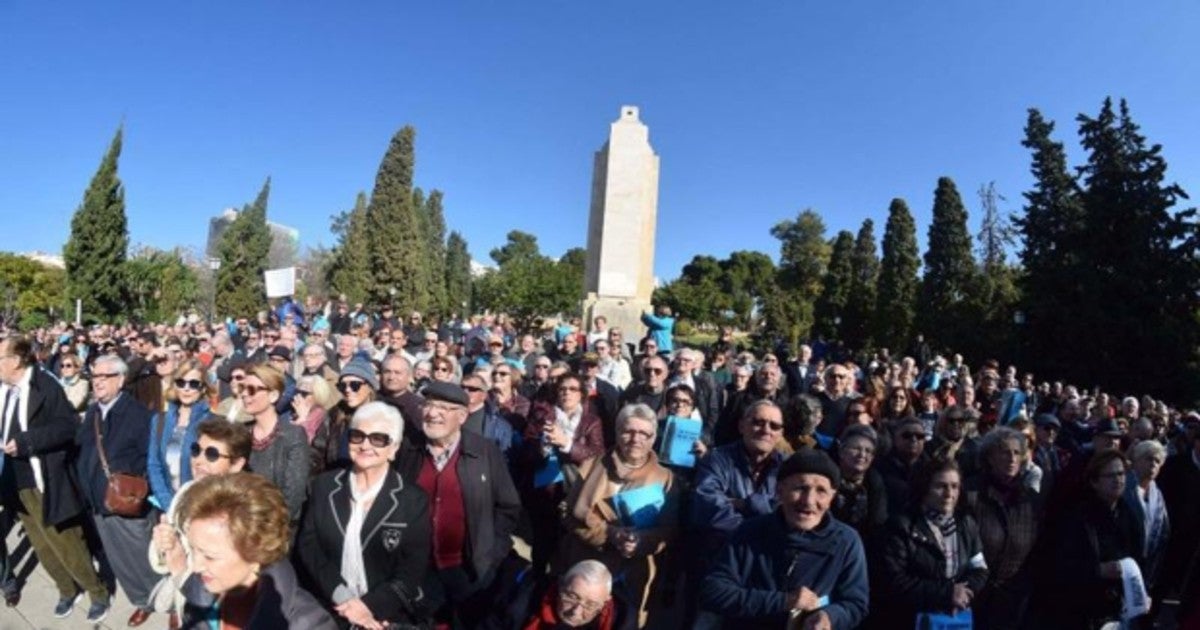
top-left (695, 449), bottom-right (868, 630)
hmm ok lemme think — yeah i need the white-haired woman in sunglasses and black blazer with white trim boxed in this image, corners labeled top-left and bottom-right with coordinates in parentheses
top-left (296, 402), bottom-right (430, 630)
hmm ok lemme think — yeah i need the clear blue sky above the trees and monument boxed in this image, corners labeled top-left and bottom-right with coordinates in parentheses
top-left (0, 0), bottom-right (1200, 278)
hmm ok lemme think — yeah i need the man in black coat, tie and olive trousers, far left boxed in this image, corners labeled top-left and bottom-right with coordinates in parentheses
top-left (0, 337), bottom-right (109, 623)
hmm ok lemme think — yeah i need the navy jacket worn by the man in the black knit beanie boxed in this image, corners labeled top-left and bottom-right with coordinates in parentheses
top-left (700, 511), bottom-right (869, 630)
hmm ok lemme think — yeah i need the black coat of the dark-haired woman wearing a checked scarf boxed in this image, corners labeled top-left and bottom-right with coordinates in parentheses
top-left (872, 510), bottom-right (988, 625)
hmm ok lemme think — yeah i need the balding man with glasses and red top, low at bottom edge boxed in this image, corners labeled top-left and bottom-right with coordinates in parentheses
top-left (501, 560), bottom-right (637, 630)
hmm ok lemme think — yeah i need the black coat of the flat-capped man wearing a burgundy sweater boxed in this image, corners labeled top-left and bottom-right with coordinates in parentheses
top-left (394, 431), bottom-right (521, 580)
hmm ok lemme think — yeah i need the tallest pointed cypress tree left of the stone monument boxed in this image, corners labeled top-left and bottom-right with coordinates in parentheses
top-left (366, 126), bottom-right (430, 311)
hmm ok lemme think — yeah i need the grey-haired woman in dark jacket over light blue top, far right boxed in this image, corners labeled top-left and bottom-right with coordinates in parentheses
top-left (1124, 439), bottom-right (1171, 590)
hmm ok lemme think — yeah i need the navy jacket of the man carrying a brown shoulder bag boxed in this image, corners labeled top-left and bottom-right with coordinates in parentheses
top-left (76, 392), bottom-right (151, 515)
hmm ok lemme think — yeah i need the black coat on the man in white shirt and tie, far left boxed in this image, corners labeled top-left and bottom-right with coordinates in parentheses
top-left (0, 367), bottom-right (83, 526)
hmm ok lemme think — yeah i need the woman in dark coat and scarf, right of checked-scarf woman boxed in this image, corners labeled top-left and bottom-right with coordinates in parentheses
top-left (964, 426), bottom-right (1042, 629)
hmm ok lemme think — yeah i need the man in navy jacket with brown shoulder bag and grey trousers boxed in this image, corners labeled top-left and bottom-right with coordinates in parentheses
top-left (74, 356), bottom-right (158, 626)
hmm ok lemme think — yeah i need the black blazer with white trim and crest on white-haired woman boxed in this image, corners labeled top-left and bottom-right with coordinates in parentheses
top-left (296, 470), bottom-right (431, 623)
